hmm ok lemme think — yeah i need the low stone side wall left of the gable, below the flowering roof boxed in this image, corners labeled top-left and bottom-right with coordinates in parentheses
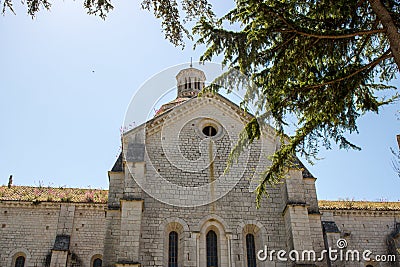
top-left (0, 201), bottom-right (105, 267)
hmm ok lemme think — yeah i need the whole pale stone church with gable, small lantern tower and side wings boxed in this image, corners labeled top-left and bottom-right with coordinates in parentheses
top-left (0, 68), bottom-right (400, 267)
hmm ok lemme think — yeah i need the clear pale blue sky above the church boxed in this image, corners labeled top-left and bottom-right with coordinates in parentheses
top-left (0, 0), bottom-right (400, 200)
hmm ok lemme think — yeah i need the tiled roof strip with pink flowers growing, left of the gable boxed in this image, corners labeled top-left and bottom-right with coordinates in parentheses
top-left (0, 186), bottom-right (108, 203)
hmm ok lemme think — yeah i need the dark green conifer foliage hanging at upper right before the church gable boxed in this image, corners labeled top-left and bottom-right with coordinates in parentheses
top-left (194, 0), bottom-right (400, 207)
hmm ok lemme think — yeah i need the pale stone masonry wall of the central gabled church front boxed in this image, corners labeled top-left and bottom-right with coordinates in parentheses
top-left (114, 93), bottom-right (322, 267)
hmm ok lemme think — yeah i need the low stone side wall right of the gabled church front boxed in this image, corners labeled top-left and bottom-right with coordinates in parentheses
top-left (320, 206), bottom-right (400, 267)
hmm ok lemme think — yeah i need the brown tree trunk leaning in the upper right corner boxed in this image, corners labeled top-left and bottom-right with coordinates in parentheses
top-left (369, 0), bottom-right (400, 71)
